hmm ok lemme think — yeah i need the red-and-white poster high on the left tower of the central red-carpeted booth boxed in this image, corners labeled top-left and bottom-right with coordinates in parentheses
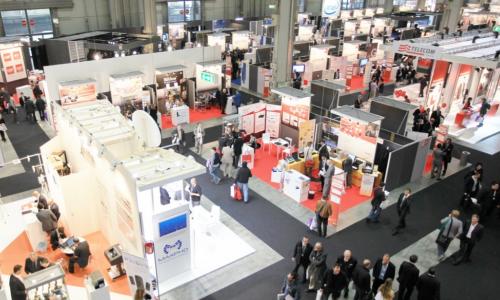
top-left (281, 97), bottom-right (311, 128)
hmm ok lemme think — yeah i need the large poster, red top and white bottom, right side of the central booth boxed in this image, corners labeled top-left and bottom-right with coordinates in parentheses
top-left (338, 117), bottom-right (380, 162)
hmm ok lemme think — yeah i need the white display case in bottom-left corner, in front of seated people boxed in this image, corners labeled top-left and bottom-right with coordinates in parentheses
top-left (24, 264), bottom-right (69, 300)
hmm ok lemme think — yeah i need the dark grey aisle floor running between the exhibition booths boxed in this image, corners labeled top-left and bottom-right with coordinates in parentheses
top-left (0, 110), bottom-right (500, 300)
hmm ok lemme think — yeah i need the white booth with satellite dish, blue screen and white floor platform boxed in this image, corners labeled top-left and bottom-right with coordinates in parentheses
top-left (40, 101), bottom-right (254, 297)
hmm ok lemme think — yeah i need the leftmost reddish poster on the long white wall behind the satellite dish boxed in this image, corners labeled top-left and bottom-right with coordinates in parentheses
top-left (59, 79), bottom-right (97, 106)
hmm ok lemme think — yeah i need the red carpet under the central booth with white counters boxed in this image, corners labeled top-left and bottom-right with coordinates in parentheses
top-left (252, 142), bottom-right (371, 223)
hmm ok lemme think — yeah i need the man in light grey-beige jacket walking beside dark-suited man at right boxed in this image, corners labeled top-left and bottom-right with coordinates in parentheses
top-left (436, 210), bottom-right (463, 261)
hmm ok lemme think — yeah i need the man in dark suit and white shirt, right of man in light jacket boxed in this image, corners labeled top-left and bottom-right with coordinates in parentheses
top-left (453, 214), bottom-right (483, 265)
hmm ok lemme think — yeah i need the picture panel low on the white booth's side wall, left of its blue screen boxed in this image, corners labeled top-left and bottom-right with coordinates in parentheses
top-left (122, 252), bottom-right (158, 299)
